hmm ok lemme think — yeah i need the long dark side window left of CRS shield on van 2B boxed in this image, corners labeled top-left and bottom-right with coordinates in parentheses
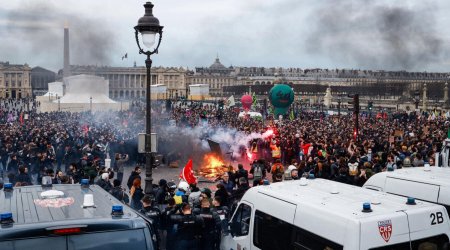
top-left (253, 210), bottom-right (343, 250)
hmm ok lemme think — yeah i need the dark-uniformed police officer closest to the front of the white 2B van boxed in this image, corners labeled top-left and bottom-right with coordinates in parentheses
top-left (194, 199), bottom-right (220, 250)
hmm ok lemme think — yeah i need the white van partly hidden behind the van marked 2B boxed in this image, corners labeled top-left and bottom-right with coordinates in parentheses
top-left (363, 166), bottom-right (450, 212)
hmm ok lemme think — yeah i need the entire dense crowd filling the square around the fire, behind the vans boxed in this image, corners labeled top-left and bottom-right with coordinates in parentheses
top-left (0, 100), bottom-right (449, 249)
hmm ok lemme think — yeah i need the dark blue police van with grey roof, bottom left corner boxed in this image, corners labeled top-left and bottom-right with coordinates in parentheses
top-left (0, 180), bottom-right (157, 250)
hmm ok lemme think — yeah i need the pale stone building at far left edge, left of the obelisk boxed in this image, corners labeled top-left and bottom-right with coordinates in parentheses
top-left (0, 62), bottom-right (32, 99)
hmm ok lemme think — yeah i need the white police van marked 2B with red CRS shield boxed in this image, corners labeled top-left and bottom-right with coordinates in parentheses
top-left (221, 178), bottom-right (450, 250)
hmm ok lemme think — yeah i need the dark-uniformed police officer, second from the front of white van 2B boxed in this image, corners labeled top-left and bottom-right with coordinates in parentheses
top-left (170, 203), bottom-right (205, 250)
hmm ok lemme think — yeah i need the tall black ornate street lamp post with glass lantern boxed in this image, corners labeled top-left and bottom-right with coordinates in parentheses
top-left (134, 2), bottom-right (163, 195)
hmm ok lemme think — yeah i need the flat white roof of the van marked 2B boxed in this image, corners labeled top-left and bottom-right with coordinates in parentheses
top-left (248, 179), bottom-right (444, 221)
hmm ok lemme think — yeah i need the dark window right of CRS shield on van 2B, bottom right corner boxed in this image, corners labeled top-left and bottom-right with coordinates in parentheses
top-left (372, 234), bottom-right (449, 250)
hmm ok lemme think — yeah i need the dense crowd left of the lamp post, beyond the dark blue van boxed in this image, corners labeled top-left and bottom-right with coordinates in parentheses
top-left (0, 100), bottom-right (145, 185)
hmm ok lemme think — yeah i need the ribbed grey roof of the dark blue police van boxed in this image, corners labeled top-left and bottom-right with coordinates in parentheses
top-left (0, 184), bottom-right (140, 227)
